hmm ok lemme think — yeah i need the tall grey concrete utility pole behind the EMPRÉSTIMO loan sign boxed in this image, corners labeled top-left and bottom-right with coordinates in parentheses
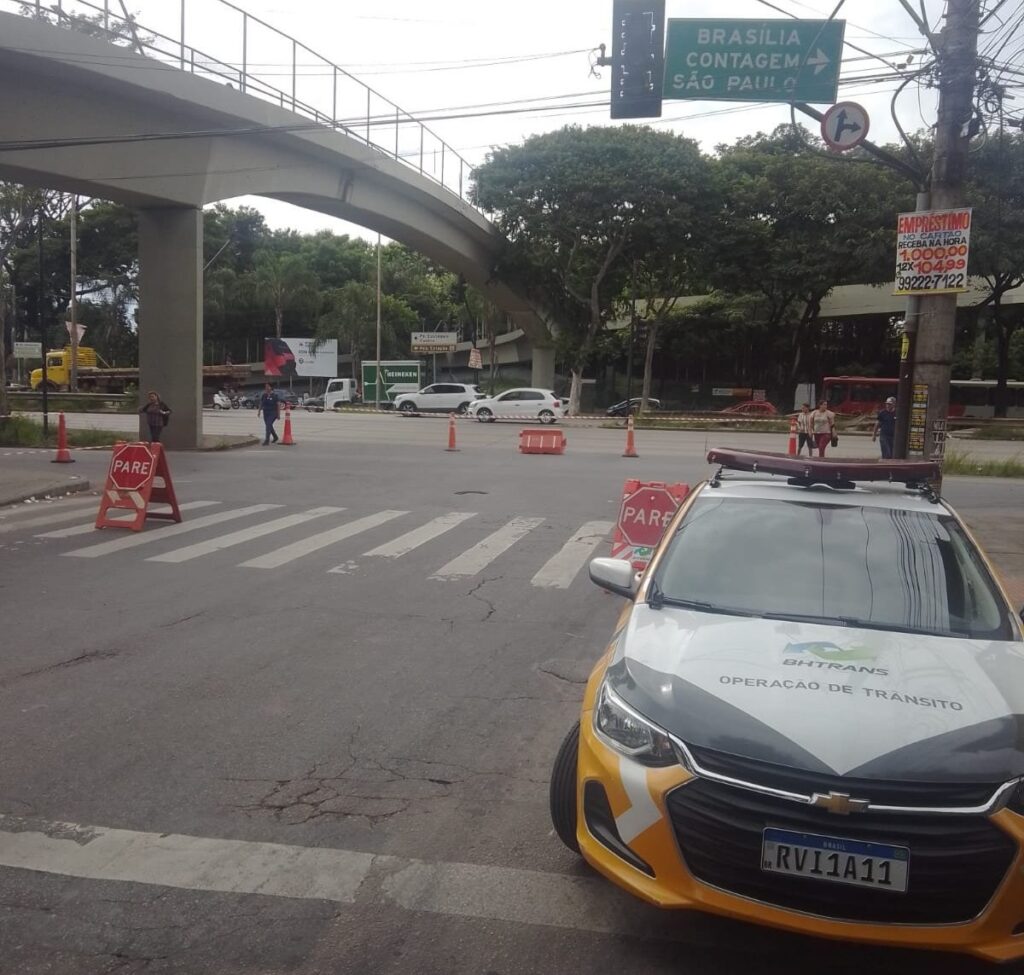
top-left (909, 0), bottom-right (980, 460)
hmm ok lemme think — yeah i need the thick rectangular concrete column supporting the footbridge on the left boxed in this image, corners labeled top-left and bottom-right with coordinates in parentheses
top-left (138, 207), bottom-right (203, 449)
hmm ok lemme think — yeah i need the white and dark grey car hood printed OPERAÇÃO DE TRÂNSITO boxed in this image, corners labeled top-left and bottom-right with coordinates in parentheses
top-left (607, 603), bottom-right (1024, 782)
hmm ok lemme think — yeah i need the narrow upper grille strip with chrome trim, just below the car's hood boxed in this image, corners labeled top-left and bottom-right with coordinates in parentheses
top-left (687, 745), bottom-right (1002, 809)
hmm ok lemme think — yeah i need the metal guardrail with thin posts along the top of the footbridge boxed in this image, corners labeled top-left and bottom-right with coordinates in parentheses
top-left (6, 0), bottom-right (473, 202)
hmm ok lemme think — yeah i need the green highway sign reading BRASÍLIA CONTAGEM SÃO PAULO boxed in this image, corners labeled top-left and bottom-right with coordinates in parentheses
top-left (665, 18), bottom-right (846, 104)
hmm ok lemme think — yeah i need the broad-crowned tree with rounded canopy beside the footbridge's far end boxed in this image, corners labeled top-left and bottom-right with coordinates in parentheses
top-left (471, 126), bottom-right (710, 412)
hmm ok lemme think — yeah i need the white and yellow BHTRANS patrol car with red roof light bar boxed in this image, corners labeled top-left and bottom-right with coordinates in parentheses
top-left (551, 451), bottom-right (1024, 961)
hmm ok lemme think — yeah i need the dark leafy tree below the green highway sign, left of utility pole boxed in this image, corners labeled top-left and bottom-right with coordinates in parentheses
top-left (712, 125), bottom-right (913, 393)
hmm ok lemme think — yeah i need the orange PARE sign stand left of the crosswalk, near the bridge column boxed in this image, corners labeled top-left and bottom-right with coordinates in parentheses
top-left (96, 442), bottom-right (181, 532)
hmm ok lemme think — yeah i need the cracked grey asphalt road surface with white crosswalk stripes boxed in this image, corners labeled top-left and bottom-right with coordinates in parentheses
top-left (0, 424), bottom-right (1021, 975)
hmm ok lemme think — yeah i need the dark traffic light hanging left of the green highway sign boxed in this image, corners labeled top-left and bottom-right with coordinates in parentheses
top-left (611, 0), bottom-right (665, 119)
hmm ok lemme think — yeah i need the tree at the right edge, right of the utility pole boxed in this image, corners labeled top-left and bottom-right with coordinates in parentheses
top-left (967, 130), bottom-right (1024, 417)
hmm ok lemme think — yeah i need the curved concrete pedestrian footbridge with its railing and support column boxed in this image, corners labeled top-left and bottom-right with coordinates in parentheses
top-left (0, 0), bottom-right (554, 447)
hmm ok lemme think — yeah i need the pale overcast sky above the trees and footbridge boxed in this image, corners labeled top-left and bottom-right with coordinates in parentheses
top-left (129, 0), bottom-right (958, 237)
